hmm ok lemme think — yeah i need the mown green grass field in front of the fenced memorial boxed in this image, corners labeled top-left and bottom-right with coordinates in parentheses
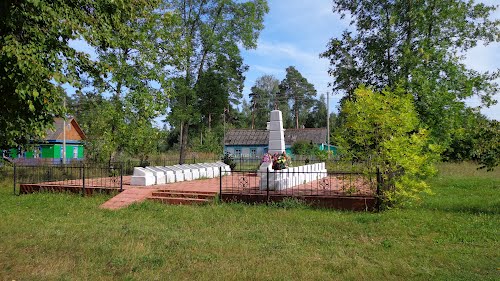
top-left (0, 161), bottom-right (500, 280)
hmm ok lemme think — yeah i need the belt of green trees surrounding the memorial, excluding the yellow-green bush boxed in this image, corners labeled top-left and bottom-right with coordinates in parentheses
top-left (0, 0), bottom-right (500, 171)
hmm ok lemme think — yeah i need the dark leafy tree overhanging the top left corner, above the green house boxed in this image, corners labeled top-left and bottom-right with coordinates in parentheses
top-left (0, 0), bottom-right (115, 148)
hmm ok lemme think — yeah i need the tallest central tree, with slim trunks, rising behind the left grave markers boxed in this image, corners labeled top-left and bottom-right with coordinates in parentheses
top-left (164, 0), bottom-right (268, 163)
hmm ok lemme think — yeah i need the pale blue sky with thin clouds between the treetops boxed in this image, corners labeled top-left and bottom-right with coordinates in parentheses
top-left (242, 0), bottom-right (500, 120)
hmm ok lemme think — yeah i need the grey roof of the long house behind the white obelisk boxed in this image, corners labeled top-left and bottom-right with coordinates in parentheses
top-left (224, 128), bottom-right (327, 145)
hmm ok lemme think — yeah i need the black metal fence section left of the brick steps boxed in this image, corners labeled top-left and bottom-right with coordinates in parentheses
top-left (12, 163), bottom-right (123, 194)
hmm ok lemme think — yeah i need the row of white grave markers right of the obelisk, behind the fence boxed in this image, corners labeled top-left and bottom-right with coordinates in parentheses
top-left (259, 162), bottom-right (328, 190)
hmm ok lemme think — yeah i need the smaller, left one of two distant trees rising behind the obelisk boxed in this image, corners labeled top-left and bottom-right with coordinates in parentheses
top-left (249, 75), bottom-right (280, 129)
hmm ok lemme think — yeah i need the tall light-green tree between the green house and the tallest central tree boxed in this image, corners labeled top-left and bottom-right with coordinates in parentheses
top-left (81, 1), bottom-right (169, 161)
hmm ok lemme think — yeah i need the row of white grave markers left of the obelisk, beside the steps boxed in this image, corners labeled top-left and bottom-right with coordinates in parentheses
top-left (130, 162), bottom-right (231, 186)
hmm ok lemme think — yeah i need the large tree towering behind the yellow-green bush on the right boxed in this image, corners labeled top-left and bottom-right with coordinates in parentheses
top-left (321, 0), bottom-right (500, 146)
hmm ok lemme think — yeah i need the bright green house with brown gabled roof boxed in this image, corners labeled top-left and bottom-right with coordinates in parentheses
top-left (4, 118), bottom-right (85, 163)
